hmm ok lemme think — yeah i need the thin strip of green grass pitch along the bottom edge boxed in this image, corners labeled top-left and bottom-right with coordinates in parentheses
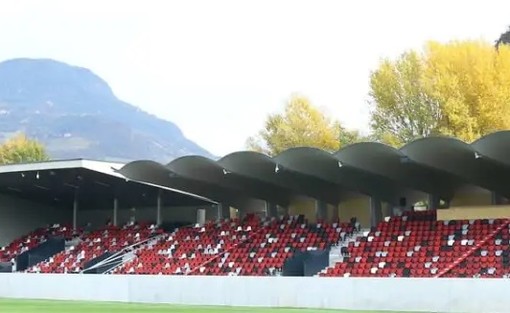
top-left (0, 299), bottom-right (416, 313)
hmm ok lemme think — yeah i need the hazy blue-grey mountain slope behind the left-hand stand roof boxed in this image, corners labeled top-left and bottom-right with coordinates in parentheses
top-left (0, 59), bottom-right (212, 162)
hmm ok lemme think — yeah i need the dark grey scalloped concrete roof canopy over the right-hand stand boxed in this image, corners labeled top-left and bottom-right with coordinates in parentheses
top-left (120, 131), bottom-right (510, 205)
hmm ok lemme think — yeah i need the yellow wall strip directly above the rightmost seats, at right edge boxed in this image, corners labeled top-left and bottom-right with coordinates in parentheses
top-left (437, 205), bottom-right (510, 221)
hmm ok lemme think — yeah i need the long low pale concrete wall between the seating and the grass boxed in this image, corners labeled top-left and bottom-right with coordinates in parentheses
top-left (0, 273), bottom-right (510, 313)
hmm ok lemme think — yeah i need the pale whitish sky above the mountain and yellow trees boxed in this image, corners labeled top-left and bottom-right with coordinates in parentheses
top-left (0, 0), bottom-right (510, 155)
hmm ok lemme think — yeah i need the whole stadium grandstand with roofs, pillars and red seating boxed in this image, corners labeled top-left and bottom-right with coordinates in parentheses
top-left (0, 131), bottom-right (510, 310)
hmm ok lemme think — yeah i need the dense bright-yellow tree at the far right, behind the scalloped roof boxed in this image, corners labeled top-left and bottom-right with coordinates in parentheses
top-left (425, 42), bottom-right (510, 141)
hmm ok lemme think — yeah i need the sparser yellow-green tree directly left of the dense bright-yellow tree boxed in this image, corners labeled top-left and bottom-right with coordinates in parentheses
top-left (370, 51), bottom-right (441, 146)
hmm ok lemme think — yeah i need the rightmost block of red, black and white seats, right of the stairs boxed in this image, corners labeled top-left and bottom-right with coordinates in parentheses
top-left (320, 210), bottom-right (510, 277)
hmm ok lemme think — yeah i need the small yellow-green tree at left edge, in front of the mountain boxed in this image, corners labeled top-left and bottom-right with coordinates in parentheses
top-left (0, 134), bottom-right (49, 164)
